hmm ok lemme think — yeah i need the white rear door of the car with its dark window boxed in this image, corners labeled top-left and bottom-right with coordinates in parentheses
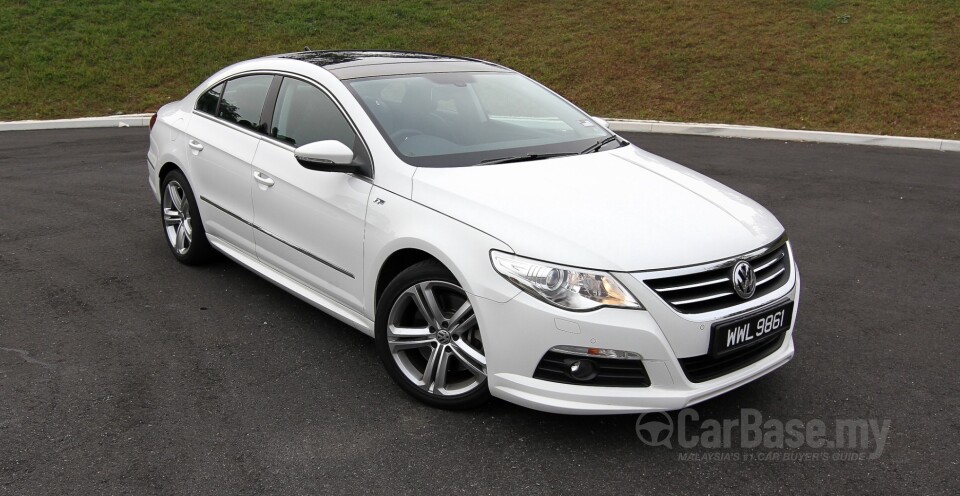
top-left (187, 74), bottom-right (274, 255)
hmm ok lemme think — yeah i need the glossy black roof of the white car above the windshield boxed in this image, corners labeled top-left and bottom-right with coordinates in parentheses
top-left (274, 50), bottom-right (512, 79)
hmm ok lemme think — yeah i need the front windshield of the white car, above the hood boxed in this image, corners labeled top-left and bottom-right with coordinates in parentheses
top-left (345, 72), bottom-right (620, 167)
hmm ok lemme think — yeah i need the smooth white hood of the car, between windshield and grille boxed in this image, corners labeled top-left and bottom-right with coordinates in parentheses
top-left (412, 145), bottom-right (783, 272)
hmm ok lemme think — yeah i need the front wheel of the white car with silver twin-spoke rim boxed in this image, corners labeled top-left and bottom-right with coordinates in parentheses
top-left (375, 261), bottom-right (490, 410)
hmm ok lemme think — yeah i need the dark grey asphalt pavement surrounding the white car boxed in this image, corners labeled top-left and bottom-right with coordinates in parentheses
top-left (0, 128), bottom-right (960, 495)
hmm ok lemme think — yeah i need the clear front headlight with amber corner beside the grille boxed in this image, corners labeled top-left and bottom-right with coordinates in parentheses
top-left (490, 251), bottom-right (643, 311)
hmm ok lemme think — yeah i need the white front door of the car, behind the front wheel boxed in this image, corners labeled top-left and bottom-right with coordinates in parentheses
top-left (253, 77), bottom-right (372, 311)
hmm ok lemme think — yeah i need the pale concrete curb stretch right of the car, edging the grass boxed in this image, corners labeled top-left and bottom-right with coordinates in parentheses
top-left (607, 119), bottom-right (960, 152)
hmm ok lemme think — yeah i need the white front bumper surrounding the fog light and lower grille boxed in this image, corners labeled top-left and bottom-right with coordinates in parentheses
top-left (475, 266), bottom-right (800, 415)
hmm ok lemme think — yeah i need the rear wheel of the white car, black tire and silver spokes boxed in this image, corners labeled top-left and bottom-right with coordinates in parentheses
top-left (160, 170), bottom-right (214, 265)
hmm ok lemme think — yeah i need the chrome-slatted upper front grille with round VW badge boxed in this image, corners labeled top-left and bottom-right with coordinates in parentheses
top-left (644, 239), bottom-right (793, 313)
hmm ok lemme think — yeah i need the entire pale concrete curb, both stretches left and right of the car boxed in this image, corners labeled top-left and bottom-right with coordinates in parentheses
top-left (0, 114), bottom-right (960, 152)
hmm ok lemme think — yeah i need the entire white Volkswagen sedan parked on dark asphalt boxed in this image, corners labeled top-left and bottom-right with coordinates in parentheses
top-left (147, 51), bottom-right (799, 414)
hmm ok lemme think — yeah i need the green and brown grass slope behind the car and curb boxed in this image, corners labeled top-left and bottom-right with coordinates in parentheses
top-left (0, 0), bottom-right (960, 139)
